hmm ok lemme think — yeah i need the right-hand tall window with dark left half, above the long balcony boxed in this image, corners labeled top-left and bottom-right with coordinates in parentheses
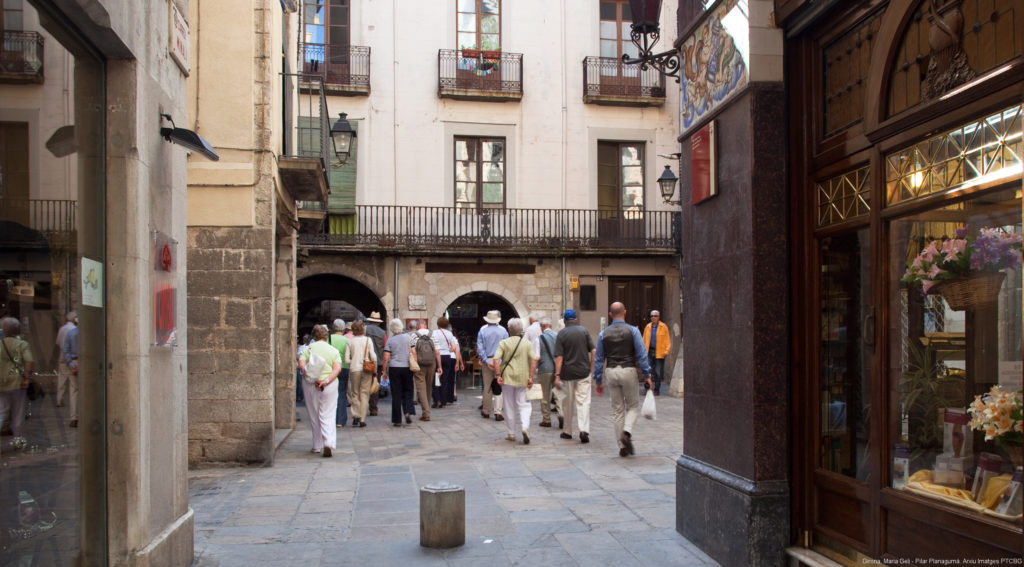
top-left (597, 141), bottom-right (644, 219)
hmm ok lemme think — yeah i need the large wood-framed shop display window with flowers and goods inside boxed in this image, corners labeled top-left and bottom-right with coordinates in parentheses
top-left (888, 183), bottom-right (1024, 517)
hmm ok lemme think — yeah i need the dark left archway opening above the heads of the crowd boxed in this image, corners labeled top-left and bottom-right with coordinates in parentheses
top-left (298, 273), bottom-right (388, 335)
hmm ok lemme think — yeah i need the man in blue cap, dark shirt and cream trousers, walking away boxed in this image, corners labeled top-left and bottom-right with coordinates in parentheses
top-left (557, 309), bottom-right (594, 443)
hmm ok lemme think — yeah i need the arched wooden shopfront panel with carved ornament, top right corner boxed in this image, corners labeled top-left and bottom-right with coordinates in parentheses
top-left (889, 0), bottom-right (1024, 116)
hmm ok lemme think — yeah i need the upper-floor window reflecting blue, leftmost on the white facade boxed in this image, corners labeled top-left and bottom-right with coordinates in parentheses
top-left (302, 0), bottom-right (350, 73)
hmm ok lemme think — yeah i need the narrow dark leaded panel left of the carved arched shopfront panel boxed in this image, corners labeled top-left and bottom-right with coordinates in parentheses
top-left (822, 11), bottom-right (882, 136)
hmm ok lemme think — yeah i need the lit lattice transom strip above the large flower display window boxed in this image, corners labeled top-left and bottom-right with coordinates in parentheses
top-left (886, 105), bottom-right (1022, 205)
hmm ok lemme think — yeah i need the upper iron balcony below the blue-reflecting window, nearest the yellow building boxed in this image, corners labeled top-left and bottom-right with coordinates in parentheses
top-left (299, 43), bottom-right (370, 96)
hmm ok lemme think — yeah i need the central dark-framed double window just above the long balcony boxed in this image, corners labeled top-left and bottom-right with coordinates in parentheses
top-left (455, 136), bottom-right (505, 209)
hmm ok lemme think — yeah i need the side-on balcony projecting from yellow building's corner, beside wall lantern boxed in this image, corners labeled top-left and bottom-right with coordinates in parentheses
top-left (278, 74), bottom-right (331, 207)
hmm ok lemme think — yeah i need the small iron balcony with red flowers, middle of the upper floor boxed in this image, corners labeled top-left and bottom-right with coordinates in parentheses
top-left (437, 49), bottom-right (522, 102)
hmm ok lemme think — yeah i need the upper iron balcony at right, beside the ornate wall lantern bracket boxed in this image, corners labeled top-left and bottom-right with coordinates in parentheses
top-left (583, 57), bottom-right (665, 106)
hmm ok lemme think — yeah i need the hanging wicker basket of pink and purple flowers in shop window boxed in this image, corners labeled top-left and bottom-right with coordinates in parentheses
top-left (900, 227), bottom-right (1021, 310)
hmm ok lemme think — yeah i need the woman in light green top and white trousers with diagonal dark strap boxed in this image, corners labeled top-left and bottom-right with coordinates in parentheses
top-left (490, 319), bottom-right (537, 445)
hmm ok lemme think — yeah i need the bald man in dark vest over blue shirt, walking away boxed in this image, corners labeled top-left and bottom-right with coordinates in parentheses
top-left (594, 301), bottom-right (650, 456)
